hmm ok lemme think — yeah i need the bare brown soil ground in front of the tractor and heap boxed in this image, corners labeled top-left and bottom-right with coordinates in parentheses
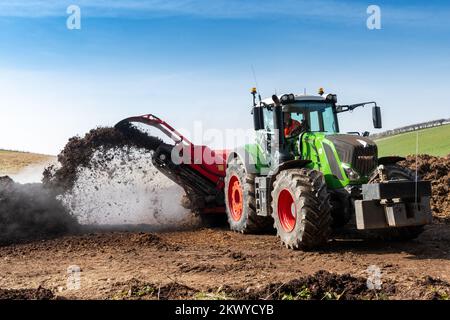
top-left (0, 224), bottom-right (450, 299)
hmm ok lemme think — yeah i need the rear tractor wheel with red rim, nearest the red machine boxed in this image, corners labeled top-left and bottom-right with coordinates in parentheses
top-left (225, 158), bottom-right (272, 233)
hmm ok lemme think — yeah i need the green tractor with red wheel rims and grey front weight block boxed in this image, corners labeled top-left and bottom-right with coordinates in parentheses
top-left (224, 88), bottom-right (432, 249)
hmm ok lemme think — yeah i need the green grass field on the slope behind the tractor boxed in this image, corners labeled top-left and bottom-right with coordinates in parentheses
top-left (375, 125), bottom-right (450, 156)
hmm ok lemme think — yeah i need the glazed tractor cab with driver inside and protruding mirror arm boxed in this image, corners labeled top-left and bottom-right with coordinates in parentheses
top-left (252, 89), bottom-right (381, 162)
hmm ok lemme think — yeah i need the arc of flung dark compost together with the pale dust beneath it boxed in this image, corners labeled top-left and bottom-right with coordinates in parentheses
top-left (44, 124), bottom-right (197, 226)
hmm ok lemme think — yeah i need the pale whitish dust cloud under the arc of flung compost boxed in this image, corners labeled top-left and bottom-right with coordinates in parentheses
top-left (60, 147), bottom-right (196, 228)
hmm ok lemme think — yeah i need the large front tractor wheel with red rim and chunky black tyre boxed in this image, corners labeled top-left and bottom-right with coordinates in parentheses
top-left (272, 168), bottom-right (331, 249)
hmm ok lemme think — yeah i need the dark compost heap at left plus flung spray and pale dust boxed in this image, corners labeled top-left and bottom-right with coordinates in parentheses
top-left (0, 125), bottom-right (197, 243)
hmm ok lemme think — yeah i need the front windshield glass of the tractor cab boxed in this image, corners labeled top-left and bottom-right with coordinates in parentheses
top-left (283, 102), bottom-right (338, 133)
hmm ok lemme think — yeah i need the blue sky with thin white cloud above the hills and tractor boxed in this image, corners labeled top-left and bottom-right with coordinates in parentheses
top-left (0, 0), bottom-right (450, 154)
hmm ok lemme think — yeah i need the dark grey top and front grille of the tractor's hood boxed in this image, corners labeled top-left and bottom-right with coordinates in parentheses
top-left (327, 134), bottom-right (378, 176)
